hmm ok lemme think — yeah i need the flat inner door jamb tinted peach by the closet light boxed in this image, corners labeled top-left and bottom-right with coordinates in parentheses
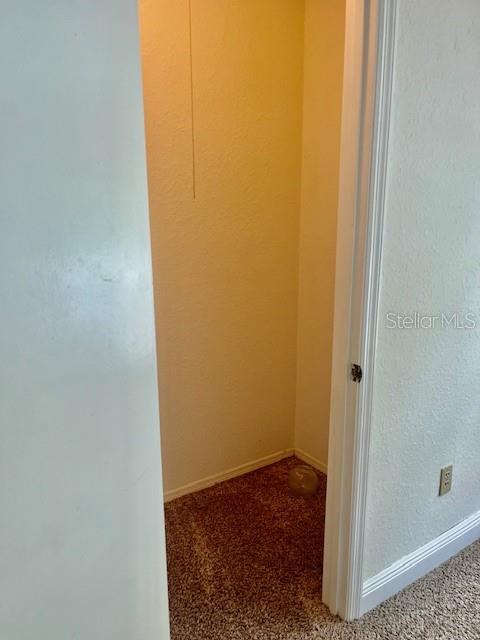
top-left (322, 0), bottom-right (372, 614)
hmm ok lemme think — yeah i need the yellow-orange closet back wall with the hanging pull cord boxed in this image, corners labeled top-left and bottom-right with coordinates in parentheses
top-left (140, 0), bottom-right (304, 491)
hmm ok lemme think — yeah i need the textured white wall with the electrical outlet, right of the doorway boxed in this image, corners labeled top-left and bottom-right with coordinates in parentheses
top-left (365, 0), bottom-right (480, 577)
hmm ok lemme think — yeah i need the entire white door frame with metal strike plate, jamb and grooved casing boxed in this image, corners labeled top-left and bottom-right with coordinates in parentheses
top-left (323, 0), bottom-right (396, 620)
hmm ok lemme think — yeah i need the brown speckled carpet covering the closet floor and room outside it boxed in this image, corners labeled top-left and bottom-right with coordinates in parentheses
top-left (165, 458), bottom-right (480, 640)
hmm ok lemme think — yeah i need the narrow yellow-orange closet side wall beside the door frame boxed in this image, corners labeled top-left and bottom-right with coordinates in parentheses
top-left (295, 0), bottom-right (345, 469)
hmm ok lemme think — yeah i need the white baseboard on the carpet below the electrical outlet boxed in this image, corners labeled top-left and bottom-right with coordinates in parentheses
top-left (360, 511), bottom-right (480, 615)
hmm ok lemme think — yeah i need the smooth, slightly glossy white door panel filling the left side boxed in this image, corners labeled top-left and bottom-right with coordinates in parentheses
top-left (0, 0), bottom-right (167, 640)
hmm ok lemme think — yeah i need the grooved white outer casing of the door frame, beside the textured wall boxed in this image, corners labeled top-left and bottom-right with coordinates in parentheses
top-left (346, 0), bottom-right (396, 619)
